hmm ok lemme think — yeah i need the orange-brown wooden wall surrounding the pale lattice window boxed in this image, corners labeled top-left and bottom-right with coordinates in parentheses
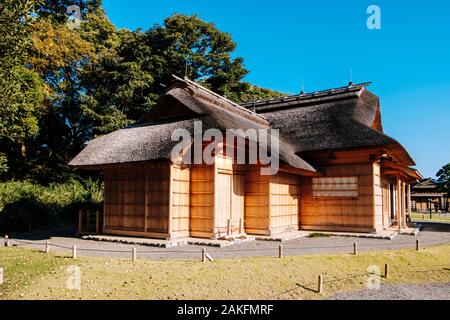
top-left (300, 164), bottom-right (378, 232)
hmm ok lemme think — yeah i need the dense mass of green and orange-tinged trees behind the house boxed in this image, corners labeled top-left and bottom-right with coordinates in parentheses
top-left (0, 0), bottom-right (280, 183)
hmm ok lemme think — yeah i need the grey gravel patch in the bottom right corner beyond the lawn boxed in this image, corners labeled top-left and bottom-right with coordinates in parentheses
top-left (330, 283), bottom-right (450, 300)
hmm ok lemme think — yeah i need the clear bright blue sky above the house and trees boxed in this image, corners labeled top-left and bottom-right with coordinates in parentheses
top-left (104, 0), bottom-right (450, 177)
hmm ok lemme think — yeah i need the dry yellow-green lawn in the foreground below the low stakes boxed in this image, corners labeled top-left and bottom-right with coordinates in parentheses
top-left (0, 245), bottom-right (450, 300)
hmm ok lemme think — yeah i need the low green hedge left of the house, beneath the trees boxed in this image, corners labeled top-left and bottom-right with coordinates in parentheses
top-left (0, 179), bottom-right (103, 233)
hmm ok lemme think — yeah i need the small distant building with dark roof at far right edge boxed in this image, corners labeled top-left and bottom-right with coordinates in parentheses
top-left (411, 178), bottom-right (447, 212)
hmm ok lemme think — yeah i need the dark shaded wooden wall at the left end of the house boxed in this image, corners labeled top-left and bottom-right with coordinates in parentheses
top-left (104, 164), bottom-right (170, 238)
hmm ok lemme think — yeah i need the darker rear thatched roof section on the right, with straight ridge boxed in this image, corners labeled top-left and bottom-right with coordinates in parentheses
top-left (245, 83), bottom-right (415, 166)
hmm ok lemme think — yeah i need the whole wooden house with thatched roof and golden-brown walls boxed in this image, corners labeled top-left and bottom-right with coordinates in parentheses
top-left (70, 77), bottom-right (421, 238)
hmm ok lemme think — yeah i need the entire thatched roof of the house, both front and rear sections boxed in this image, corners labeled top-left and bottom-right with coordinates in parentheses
top-left (69, 77), bottom-right (413, 173)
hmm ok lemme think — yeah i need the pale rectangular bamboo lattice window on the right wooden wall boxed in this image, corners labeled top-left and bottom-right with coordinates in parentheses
top-left (313, 177), bottom-right (359, 198)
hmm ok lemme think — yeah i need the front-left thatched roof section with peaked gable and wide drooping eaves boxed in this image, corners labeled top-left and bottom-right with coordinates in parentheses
top-left (69, 78), bottom-right (316, 172)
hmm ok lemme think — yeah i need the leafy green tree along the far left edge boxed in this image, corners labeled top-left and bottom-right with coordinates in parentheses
top-left (0, 0), bottom-right (45, 176)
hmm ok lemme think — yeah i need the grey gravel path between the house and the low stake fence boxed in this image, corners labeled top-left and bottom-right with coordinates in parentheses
top-left (7, 223), bottom-right (450, 260)
